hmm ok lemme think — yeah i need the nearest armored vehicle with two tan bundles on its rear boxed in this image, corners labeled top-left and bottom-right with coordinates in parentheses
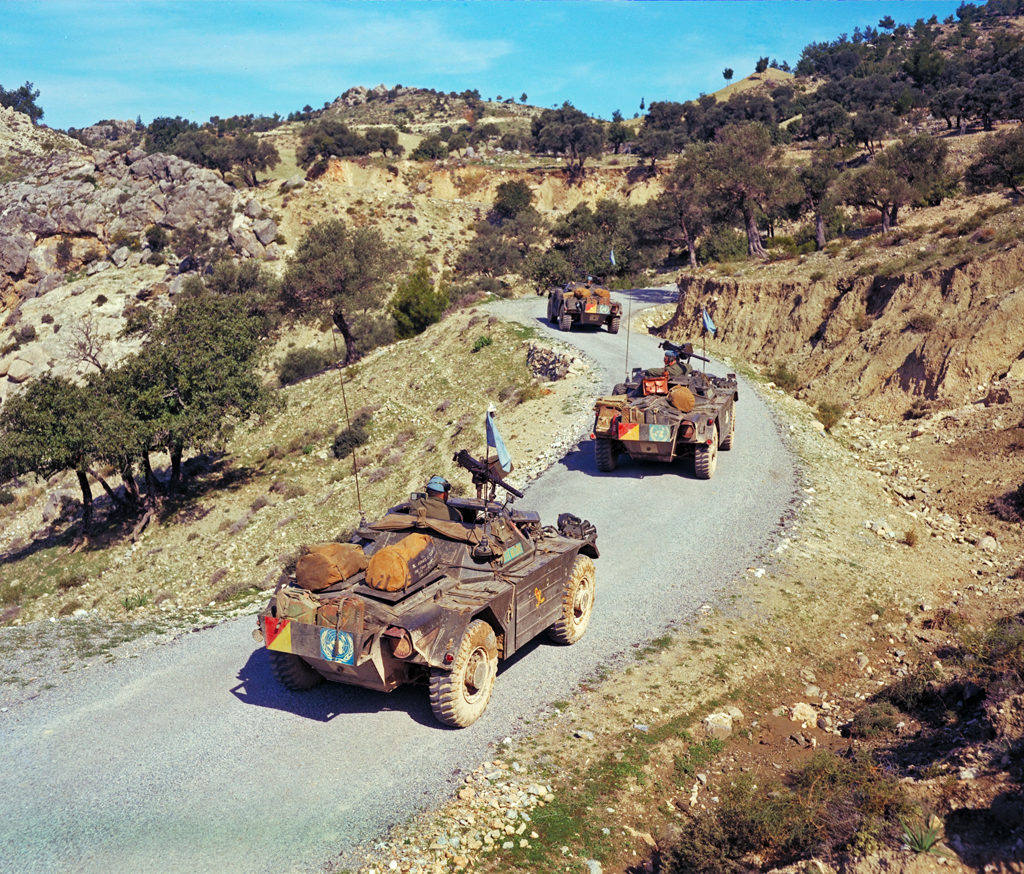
top-left (254, 450), bottom-right (598, 728)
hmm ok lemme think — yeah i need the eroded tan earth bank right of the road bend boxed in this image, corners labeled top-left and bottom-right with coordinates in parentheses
top-left (657, 245), bottom-right (1024, 417)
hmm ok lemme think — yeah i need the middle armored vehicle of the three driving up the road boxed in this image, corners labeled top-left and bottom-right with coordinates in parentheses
top-left (593, 341), bottom-right (739, 479)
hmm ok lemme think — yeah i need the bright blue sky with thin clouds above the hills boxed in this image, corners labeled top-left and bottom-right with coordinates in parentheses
top-left (0, 0), bottom-right (959, 129)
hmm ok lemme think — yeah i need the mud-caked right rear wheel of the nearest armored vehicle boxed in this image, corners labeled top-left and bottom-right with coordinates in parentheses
top-left (430, 619), bottom-right (498, 729)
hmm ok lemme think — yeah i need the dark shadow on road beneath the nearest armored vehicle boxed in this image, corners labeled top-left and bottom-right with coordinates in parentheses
top-left (228, 648), bottom-right (438, 728)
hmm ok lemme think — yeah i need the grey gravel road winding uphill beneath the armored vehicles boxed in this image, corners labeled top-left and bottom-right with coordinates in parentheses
top-left (0, 290), bottom-right (797, 874)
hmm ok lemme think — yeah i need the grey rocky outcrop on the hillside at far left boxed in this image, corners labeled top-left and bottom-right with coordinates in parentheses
top-left (0, 110), bottom-right (278, 307)
